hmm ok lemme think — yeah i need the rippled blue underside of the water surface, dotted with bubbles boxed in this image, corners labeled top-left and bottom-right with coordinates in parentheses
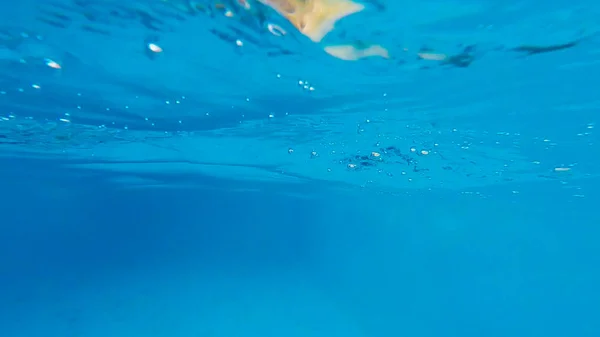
top-left (0, 1), bottom-right (599, 190)
